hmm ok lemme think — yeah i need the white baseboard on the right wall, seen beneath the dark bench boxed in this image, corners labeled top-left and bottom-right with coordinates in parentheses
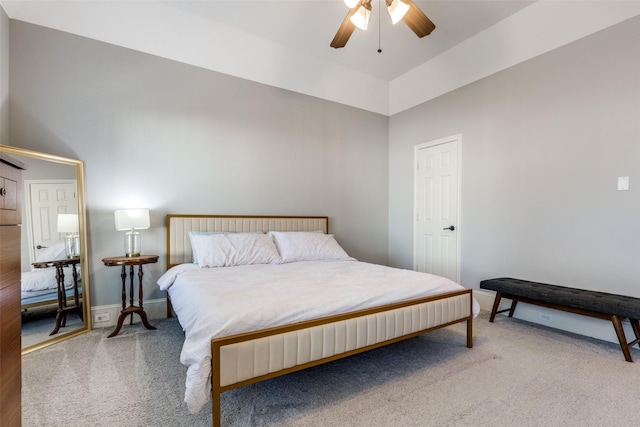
top-left (473, 289), bottom-right (635, 344)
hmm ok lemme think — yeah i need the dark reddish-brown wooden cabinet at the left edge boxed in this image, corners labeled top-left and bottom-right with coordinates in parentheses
top-left (0, 153), bottom-right (25, 427)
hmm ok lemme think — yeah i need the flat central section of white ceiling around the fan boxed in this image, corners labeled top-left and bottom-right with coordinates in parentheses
top-left (162, 0), bottom-right (533, 81)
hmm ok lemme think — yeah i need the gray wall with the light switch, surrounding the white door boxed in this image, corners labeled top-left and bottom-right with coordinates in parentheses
top-left (389, 18), bottom-right (640, 297)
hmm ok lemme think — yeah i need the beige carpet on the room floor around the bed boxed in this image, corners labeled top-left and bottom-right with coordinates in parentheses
top-left (23, 313), bottom-right (640, 427)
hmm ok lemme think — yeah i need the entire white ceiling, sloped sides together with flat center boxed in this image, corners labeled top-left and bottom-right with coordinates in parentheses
top-left (0, 0), bottom-right (640, 115)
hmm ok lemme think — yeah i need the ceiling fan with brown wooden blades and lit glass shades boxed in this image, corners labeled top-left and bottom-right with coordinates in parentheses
top-left (330, 0), bottom-right (436, 49)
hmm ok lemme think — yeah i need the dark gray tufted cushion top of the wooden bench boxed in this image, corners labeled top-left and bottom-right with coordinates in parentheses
top-left (480, 277), bottom-right (640, 319)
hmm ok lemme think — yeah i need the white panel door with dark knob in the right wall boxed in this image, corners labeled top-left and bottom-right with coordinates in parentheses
top-left (414, 136), bottom-right (460, 282)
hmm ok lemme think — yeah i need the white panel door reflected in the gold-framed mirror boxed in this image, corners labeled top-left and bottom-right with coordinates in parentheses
top-left (25, 179), bottom-right (78, 262)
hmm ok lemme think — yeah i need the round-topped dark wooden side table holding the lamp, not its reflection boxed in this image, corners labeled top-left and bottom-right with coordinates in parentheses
top-left (102, 255), bottom-right (158, 338)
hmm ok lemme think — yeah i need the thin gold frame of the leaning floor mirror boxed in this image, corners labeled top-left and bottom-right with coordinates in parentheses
top-left (0, 144), bottom-right (92, 355)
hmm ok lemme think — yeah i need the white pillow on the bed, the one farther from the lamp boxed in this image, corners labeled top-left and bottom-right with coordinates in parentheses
top-left (269, 231), bottom-right (355, 262)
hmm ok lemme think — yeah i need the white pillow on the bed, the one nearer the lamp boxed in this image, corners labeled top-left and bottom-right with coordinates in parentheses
top-left (190, 233), bottom-right (282, 268)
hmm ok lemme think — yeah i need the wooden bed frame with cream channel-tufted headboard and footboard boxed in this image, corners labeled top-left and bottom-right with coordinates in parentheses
top-left (167, 215), bottom-right (473, 427)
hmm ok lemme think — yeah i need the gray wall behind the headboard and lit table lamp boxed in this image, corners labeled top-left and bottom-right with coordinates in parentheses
top-left (9, 21), bottom-right (388, 306)
